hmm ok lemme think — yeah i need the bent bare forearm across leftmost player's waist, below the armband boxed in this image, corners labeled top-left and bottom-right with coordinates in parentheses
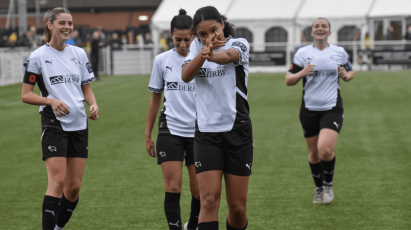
top-left (21, 83), bottom-right (70, 117)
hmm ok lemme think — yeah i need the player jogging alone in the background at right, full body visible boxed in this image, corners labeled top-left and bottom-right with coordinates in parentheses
top-left (285, 18), bottom-right (354, 204)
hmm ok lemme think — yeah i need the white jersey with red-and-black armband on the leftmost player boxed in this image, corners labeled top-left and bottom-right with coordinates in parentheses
top-left (23, 44), bottom-right (94, 131)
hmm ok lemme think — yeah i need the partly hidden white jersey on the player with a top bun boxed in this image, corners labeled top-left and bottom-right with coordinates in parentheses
top-left (148, 49), bottom-right (196, 137)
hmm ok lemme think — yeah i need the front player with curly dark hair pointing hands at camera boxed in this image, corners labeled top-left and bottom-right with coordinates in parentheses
top-left (181, 6), bottom-right (253, 230)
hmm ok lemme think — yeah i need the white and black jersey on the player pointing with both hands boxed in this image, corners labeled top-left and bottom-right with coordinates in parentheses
top-left (184, 37), bottom-right (250, 132)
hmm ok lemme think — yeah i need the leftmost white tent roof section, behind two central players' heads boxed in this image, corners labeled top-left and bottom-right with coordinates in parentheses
top-left (151, 0), bottom-right (235, 30)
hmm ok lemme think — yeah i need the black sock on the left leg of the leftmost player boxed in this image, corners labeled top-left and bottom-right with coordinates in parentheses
top-left (42, 195), bottom-right (60, 230)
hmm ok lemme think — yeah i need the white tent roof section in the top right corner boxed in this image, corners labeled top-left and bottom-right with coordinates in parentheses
top-left (368, 0), bottom-right (411, 17)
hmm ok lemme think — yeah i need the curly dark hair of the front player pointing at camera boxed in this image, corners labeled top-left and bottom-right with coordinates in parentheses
top-left (193, 6), bottom-right (235, 38)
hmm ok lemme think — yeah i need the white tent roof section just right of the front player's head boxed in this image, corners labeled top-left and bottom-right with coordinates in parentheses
top-left (226, 0), bottom-right (303, 21)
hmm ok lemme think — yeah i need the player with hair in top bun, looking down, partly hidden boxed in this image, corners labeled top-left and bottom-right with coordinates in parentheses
top-left (145, 9), bottom-right (200, 230)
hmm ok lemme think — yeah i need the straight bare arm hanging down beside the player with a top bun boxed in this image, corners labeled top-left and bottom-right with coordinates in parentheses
top-left (145, 92), bottom-right (161, 157)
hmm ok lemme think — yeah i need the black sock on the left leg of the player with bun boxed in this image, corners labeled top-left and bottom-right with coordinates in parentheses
top-left (164, 192), bottom-right (182, 230)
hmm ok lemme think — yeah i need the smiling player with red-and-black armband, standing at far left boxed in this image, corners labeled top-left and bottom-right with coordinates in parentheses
top-left (21, 7), bottom-right (99, 230)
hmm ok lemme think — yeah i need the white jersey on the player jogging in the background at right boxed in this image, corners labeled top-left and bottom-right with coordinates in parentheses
top-left (289, 44), bottom-right (352, 111)
